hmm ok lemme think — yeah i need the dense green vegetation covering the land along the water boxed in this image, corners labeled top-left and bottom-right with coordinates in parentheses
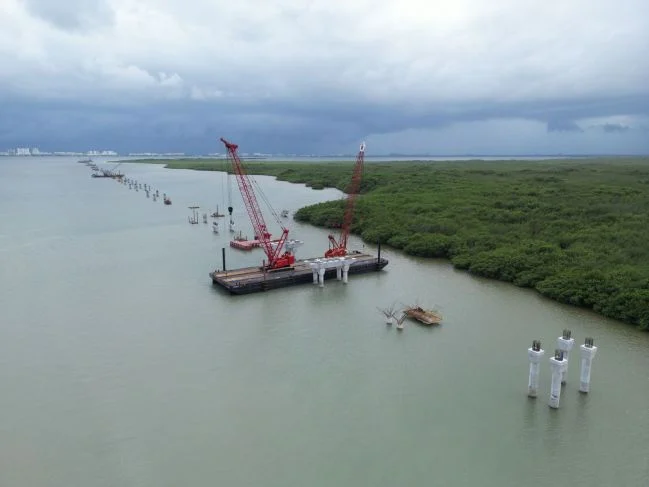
top-left (120, 158), bottom-right (649, 329)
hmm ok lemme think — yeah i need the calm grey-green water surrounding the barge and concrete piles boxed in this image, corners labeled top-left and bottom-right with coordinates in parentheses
top-left (0, 158), bottom-right (649, 487)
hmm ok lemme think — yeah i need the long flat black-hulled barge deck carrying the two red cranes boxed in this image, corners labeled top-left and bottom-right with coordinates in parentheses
top-left (210, 253), bottom-right (388, 294)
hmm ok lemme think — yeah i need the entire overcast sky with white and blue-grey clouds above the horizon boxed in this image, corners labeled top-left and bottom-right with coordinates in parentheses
top-left (0, 0), bottom-right (649, 155)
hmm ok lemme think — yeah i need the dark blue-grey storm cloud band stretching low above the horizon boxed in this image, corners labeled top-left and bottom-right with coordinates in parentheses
top-left (0, 90), bottom-right (649, 153)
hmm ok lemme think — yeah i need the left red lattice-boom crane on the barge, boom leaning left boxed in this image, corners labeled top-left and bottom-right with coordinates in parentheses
top-left (221, 137), bottom-right (295, 269)
